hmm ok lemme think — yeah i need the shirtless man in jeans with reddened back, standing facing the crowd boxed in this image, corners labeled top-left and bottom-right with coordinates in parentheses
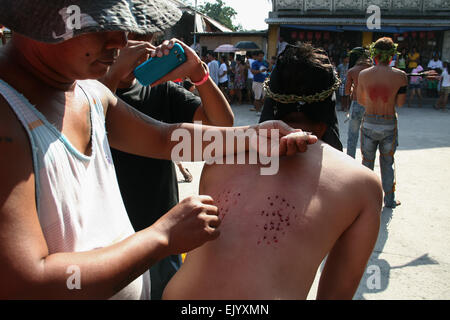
top-left (358, 38), bottom-right (408, 208)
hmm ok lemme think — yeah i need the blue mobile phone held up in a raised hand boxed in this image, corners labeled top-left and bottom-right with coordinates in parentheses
top-left (134, 43), bottom-right (186, 86)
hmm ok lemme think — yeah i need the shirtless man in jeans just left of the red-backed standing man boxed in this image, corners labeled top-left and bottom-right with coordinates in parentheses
top-left (345, 47), bottom-right (372, 158)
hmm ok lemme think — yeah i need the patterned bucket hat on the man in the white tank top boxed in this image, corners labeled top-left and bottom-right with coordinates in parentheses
top-left (0, 0), bottom-right (182, 43)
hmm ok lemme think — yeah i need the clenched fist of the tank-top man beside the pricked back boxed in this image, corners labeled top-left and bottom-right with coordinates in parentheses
top-left (155, 196), bottom-right (221, 254)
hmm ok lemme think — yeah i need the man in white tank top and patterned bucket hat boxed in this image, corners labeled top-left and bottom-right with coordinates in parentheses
top-left (0, 0), bottom-right (317, 299)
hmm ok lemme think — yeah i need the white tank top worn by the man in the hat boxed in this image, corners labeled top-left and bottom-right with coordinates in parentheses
top-left (0, 79), bottom-right (150, 300)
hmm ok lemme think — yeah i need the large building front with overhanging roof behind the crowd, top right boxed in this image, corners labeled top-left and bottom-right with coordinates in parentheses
top-left (266, 0), bottom-right (450, 64)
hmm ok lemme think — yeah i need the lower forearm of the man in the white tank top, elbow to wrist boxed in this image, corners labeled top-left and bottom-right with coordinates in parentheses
top-left (10, 227), bottom-right (170, 299)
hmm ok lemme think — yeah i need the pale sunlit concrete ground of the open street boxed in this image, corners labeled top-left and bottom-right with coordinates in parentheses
top-left (178, 105), bottom-right (450, 300)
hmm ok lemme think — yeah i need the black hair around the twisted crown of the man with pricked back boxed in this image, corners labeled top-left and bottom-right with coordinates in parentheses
top-left (260, 43), bottom-right (342, 150)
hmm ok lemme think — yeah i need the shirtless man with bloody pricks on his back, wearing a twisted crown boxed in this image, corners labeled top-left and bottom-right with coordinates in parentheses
top-left (163, 45), bottom-right (382, 300)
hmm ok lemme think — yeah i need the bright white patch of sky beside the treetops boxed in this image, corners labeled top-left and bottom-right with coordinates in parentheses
top-left (196, 0), bottom-right (272, 30)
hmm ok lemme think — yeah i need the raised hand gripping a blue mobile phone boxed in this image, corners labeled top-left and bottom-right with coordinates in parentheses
top-left (134, 39), bottom-right (207, 87)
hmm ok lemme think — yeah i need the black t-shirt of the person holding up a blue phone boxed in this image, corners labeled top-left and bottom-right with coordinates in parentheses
top-left (111, 81), bottom-right (201, 231)
